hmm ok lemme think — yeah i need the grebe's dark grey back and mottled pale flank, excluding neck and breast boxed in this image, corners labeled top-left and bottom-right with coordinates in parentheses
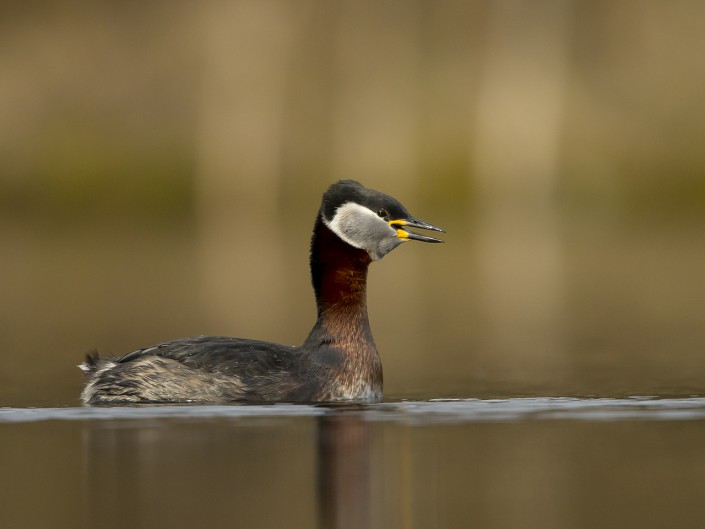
top-left (82, 336), bottom-right (321, 404)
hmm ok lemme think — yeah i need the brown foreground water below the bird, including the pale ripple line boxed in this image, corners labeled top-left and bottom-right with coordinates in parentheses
top-left (0, 397), bottom-right (705, 529)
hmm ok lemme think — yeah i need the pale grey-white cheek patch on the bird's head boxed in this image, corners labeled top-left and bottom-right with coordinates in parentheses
top-left (323, 202), bottom-right (396, 254)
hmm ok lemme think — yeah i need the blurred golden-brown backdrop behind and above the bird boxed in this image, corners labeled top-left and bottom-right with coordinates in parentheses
top-left (0, 0), bottom-right (705, 406)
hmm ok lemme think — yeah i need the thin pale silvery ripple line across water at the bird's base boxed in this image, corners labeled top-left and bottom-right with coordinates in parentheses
top-left (0, 397), bottom-right (705, 425)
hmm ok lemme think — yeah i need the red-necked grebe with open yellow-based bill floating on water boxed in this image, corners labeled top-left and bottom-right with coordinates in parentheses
top-left (79, 180), bottom-right (443, 405)
